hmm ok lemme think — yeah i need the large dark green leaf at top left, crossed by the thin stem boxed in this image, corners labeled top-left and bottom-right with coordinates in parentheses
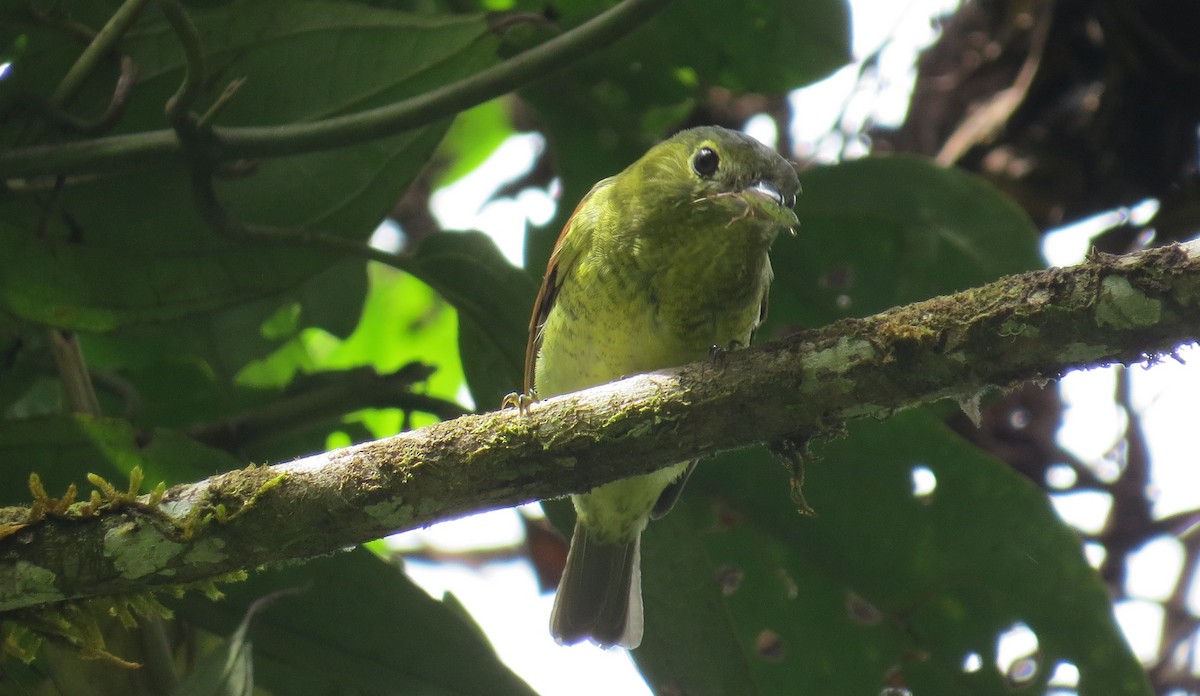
top-left (0, 0), bottom-right (496, 330)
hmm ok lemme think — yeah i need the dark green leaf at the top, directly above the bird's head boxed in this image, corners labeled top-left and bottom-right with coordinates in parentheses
top-left (522, 0), bottom-right (851, 270)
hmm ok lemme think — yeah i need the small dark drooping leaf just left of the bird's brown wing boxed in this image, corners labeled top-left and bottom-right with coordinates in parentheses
top-left (412, 232), bottom-right (538, 409)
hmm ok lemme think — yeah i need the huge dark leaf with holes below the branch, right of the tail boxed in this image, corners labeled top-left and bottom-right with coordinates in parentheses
top-left (634, 412), bottom-right (1150, 696)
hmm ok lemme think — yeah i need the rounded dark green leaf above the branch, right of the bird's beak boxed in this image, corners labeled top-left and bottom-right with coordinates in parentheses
top-left (767, 155), bottom-right (1042, 336)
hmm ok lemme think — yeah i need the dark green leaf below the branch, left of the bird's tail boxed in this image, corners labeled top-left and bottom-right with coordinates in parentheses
top-left (172, 548), bottom-right (533, 696)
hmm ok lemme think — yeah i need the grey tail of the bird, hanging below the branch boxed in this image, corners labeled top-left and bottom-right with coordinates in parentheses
top-left (550, 522), bottom-right (642, 648)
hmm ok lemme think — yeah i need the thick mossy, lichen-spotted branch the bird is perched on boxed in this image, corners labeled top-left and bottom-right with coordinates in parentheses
top-left (0, 242), bottom-right (1200, 611)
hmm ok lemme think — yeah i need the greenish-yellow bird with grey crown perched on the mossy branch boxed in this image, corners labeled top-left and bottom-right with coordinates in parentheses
top-left (526, 127), bottom-right (799, 648)
